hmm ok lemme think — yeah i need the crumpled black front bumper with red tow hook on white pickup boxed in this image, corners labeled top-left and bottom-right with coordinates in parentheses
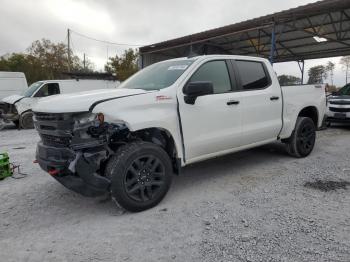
top-left (36, 142), bottom-right (110, 197)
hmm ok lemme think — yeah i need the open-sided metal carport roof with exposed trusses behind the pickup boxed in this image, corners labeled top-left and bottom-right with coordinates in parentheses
top-left (140, 0), bottom-right (350, 82)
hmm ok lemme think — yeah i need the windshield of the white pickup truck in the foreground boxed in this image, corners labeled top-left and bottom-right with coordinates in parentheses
top-left (120, 59), bottom-right (195, 90)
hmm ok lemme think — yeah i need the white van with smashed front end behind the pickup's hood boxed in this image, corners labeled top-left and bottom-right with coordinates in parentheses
top-left (2, 79), bottom-right (120, 129)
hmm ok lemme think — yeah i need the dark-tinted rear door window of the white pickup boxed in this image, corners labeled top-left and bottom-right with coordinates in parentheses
top-left (236, 61), bottom-right (270, 90)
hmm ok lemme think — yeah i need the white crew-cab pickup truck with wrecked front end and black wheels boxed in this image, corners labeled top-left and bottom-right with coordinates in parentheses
top-left (34, 55), bottom-right (326, 212)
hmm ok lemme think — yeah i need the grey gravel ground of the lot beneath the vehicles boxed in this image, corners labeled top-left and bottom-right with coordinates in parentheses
top-left (0, 127), bottom-right (350, 262)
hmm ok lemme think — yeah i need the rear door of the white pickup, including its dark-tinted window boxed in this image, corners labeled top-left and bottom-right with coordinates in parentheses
top-left (232, 60), bottom-right (282, 145)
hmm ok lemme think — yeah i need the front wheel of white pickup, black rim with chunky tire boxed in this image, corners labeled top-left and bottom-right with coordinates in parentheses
top-left (105, 142), bottom-right (173, 212)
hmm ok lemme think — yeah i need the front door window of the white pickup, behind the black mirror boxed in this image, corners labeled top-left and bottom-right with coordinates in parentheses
top-left (190, 61), bottom-right (231, 94)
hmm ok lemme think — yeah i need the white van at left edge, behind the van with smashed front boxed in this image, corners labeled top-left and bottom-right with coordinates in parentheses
top-left (0, 72), bottom-right (28, 100)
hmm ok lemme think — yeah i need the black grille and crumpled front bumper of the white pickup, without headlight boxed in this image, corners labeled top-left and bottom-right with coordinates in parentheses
top-left (34, 113), bottom-right (110, 197)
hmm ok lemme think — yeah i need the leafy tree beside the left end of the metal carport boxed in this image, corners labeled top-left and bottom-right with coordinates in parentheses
top-left (105, 48), bottom-right (138, 81)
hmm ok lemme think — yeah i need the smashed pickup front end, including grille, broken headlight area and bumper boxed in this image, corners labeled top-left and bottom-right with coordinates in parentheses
top-left (34, 112), bottom-right (129, 196)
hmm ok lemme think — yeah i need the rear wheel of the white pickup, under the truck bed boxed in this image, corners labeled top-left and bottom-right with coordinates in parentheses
top-left (287, 117), bottom-right (316, 158)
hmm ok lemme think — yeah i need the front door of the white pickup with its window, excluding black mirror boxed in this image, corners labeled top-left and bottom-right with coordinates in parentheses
top-left (178, 60), bottom-right (241, 161)
